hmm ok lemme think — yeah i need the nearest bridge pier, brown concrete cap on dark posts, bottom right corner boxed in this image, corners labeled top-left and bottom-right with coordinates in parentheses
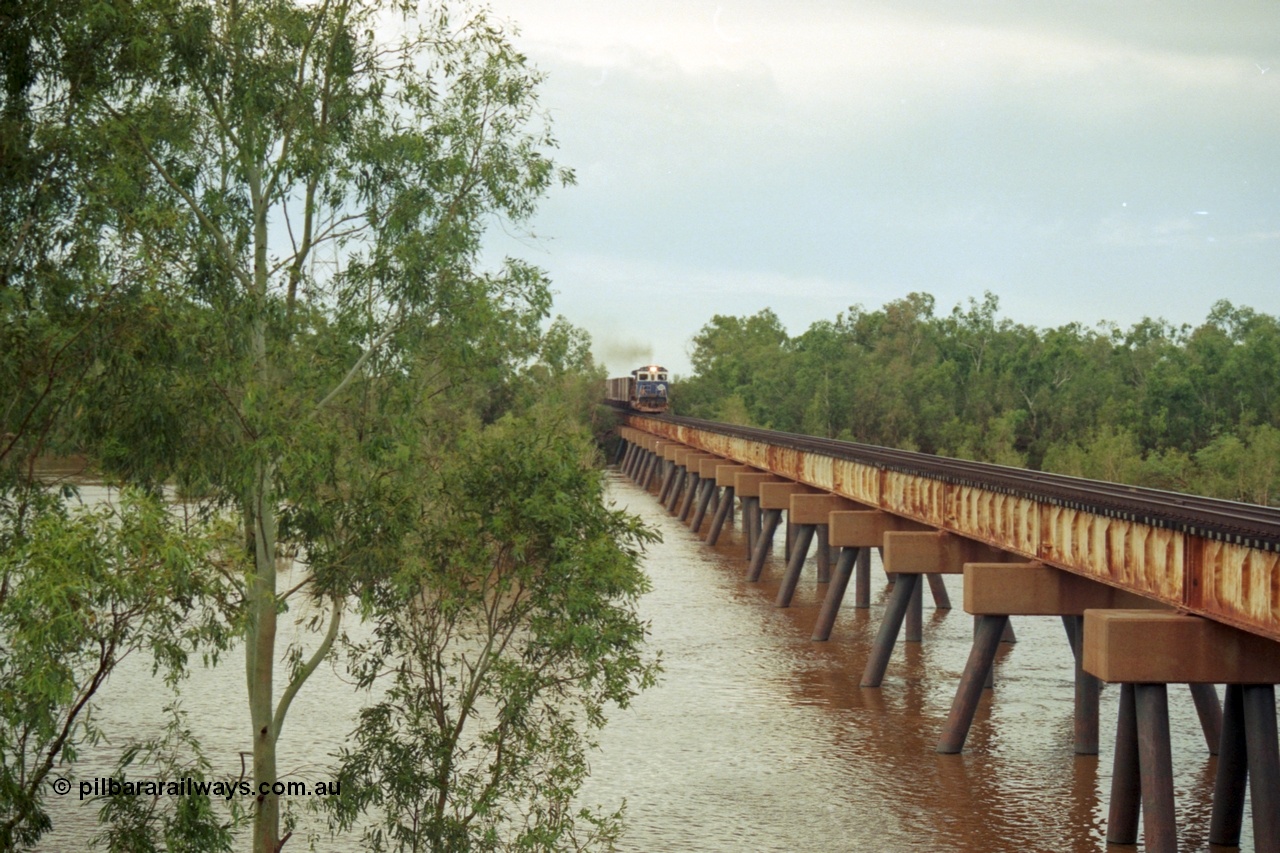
top-left (1083, 610), bottom-right (1280, 853)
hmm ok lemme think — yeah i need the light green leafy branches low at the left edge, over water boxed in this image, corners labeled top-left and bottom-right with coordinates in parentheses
top-left (0, 492), bottom-right (228, 849)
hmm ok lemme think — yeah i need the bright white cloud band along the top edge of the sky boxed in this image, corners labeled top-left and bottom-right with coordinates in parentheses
top-left (499, 0), bottom-right (1260, 109)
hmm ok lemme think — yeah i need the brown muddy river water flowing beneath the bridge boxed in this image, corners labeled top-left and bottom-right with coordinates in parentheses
top-left (32, 474), bottom-right (1252, 853)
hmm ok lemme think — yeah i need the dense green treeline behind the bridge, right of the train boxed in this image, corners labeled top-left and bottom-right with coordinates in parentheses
top-left (676, 293), bottom-right (1280, 505)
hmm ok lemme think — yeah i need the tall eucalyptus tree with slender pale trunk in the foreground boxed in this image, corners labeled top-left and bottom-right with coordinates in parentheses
top-left (8, 0), bottom-right (571, 850)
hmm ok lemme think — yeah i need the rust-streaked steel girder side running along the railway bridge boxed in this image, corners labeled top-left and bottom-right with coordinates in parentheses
top-left (626, 415), bottom-right (1280, 640)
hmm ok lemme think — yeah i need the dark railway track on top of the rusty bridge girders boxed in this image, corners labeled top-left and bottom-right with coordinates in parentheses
top-left (611, 404), bottom-right (1280, 551)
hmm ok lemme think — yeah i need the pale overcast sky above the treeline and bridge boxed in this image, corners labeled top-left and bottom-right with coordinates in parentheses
top-left (478, 0), bottom-right (1280, 375)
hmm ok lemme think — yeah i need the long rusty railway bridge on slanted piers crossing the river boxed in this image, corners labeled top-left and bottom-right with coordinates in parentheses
top-left (618, 411), bottom-right (1280, 853)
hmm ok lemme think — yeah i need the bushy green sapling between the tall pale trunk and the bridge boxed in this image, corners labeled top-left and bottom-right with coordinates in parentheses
top-left (326, 409), bottom-right (657, 852)
